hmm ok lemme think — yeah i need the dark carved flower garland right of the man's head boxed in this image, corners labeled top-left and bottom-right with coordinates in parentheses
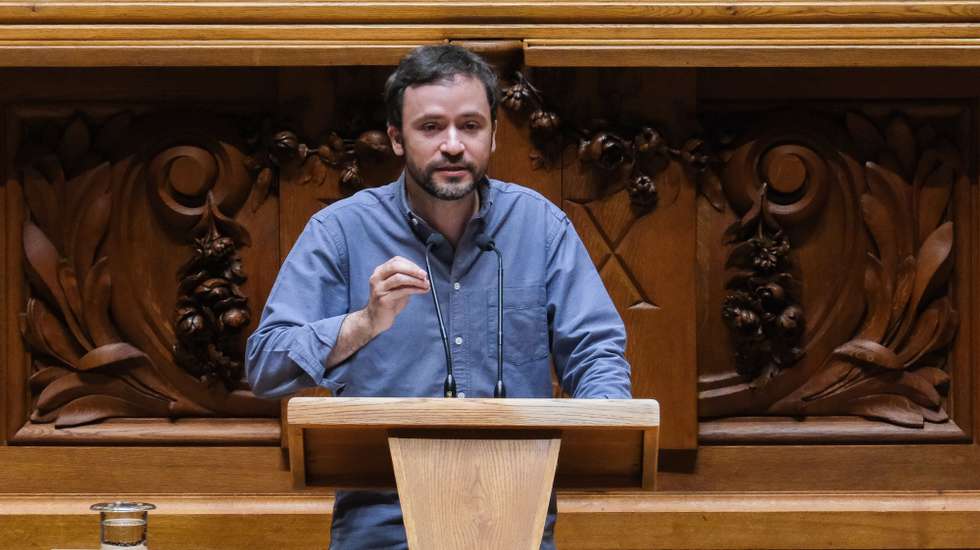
top-left (501, 71), bottom-right (724, 213)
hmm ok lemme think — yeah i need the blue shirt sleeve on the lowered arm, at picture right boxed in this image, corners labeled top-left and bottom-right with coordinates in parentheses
top-left (547, 214), bottom-right (631, 399)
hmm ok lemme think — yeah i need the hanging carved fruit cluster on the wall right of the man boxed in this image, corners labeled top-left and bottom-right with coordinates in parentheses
top-left (722, 185), bottom-right (804, 384)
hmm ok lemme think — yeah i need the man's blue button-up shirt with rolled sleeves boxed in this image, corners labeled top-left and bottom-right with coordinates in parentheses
top-left (246, 176), bottom-right (630, 550)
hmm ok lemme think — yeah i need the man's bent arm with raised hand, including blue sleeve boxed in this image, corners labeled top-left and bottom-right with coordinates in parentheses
top-left (245, 218), bottom-right (429, 398)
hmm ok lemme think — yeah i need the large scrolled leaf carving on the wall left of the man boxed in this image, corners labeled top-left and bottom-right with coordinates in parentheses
top-left (18, 112), bottom-right (278, 427)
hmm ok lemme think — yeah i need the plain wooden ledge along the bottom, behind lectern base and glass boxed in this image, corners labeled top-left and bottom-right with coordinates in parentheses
top-left (0, 492), bottom-right (980, 550)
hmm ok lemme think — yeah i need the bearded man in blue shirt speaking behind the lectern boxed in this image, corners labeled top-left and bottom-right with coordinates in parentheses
top-left (246, 45), bottom-right (630, 550)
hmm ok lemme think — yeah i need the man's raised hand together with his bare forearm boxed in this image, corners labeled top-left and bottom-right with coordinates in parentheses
top-left (326, 256), bottom-right (429, 368)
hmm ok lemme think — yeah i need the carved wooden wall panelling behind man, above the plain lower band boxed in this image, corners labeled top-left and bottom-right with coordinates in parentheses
top-left (0, 64), bottom-right (974, 449)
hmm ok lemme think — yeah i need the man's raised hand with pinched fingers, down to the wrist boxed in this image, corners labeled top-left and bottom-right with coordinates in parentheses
top-left (364, 256), bottom-right (429, 337)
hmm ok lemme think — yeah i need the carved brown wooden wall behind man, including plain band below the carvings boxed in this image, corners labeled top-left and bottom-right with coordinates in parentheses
top-left (0, 62), bottom-right (980, 547)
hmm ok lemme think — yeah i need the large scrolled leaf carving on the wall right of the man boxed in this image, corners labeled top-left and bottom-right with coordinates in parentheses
top-left (700, 112), bottom-right (964, 427)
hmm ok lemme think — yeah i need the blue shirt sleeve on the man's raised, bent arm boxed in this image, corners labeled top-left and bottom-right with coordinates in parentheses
top-left (245, 218), bottom-right (349, 398)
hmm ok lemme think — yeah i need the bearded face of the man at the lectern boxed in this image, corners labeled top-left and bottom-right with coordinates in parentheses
top-left (388, 75), bottom-right (496, 200)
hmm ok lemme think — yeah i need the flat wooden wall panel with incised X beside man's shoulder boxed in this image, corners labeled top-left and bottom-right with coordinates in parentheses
top-left (555, 70), bottom-right (697, 449)
